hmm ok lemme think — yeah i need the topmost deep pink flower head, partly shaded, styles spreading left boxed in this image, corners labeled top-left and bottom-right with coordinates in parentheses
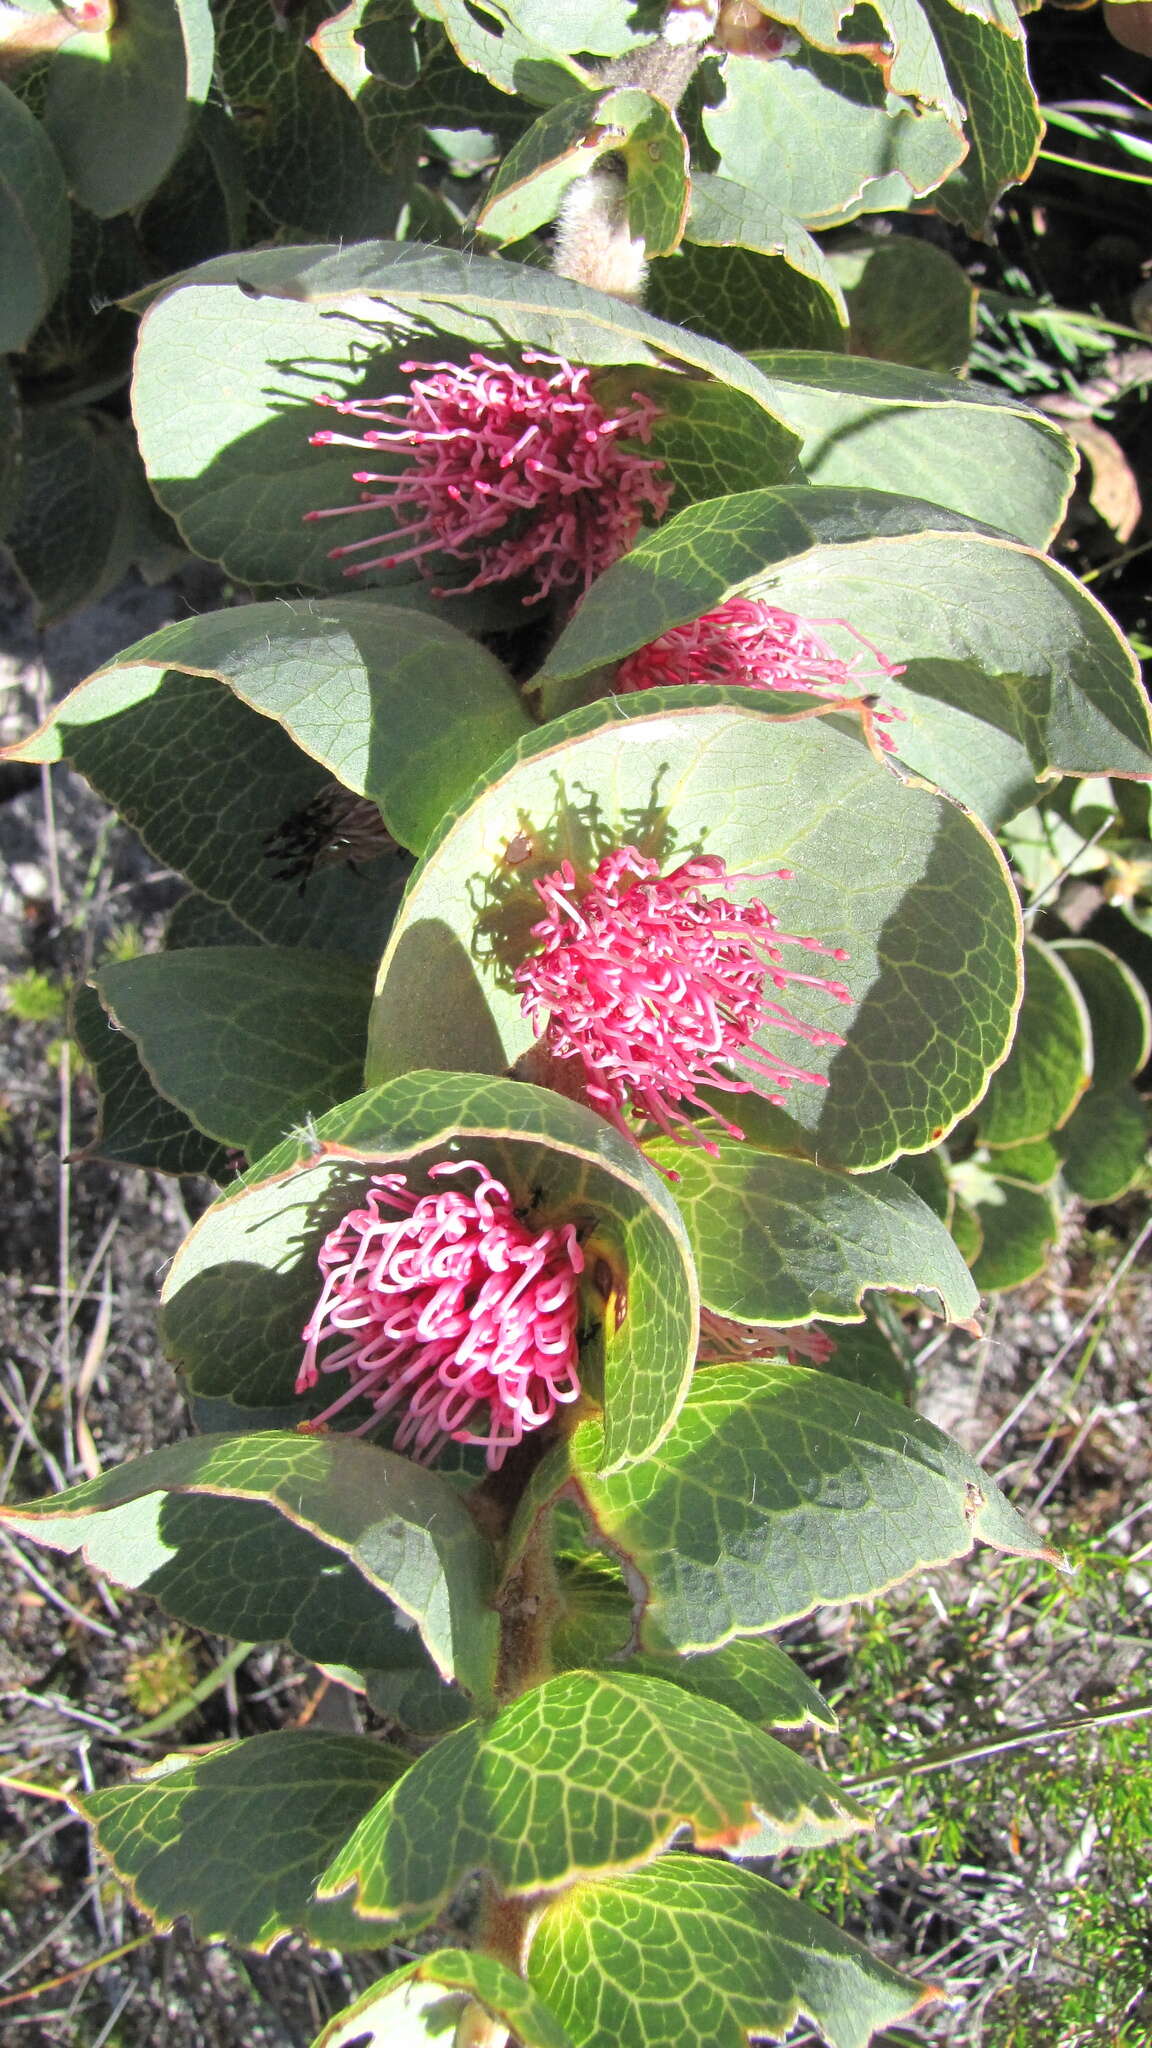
top-left (305, 350), bottom-right (672, 604)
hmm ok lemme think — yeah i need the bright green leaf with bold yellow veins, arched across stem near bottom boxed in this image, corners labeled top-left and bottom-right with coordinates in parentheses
top-left (320, 1671), bottom-right (865, 1927)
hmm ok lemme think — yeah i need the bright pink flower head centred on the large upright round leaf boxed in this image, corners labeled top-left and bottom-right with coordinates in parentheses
top-left (515, 846), bottom-right (851, 1153)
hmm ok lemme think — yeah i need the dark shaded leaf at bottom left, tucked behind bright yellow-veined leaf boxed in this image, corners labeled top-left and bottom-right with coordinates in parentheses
top-left (74, 1733), bottom-right (406, 1954)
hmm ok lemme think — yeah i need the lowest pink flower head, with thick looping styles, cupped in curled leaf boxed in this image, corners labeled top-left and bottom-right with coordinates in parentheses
top-left (295, 1159), bottom-right (584, 1470)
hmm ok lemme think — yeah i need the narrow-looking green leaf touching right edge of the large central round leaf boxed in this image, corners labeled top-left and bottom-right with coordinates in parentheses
top-left (978, 938), bottom-right (1093, 1145)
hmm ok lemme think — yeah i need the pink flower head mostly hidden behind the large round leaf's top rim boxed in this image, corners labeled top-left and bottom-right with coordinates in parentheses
top-left (613, 598), bottom-right (904, 748)
